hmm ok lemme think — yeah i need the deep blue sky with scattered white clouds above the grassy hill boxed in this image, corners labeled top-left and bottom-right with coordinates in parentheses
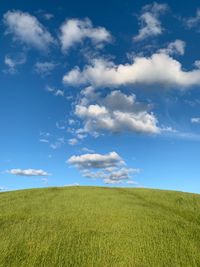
top-left (0, 0), bottom-right (200, 193)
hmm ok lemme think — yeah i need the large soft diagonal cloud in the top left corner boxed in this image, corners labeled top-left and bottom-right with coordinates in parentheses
top-left (4, 10), bottom-right (54, 50)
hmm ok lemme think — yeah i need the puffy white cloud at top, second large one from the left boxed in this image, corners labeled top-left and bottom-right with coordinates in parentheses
top-left (59, 18), bottom-right (111, 52)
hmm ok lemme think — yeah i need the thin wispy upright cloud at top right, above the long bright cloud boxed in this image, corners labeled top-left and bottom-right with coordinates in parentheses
top-left (133, 2), bottom-right (168, 41)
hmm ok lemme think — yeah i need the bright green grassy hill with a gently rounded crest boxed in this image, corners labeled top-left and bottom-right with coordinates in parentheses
top-left (0, 187), bottom-right (200, 267)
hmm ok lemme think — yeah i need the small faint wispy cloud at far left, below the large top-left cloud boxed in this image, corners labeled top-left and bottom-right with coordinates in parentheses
top-left (4, 54), bottom-right (26, 74)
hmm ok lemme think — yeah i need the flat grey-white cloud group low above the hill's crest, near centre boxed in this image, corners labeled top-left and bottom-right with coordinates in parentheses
top-left (68, 152), bottom-right (139, 184)
